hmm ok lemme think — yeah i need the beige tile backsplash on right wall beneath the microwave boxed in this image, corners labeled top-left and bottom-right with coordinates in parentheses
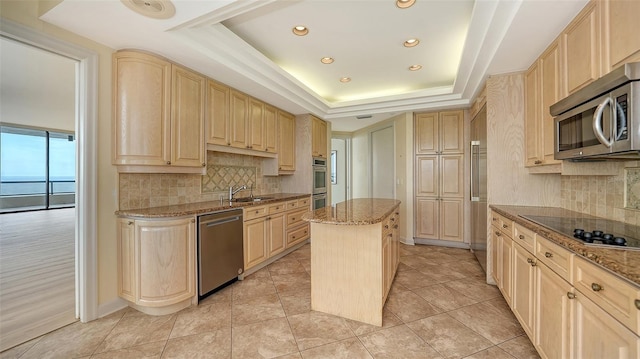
top-left (560, 168), bottom-right (640, 225)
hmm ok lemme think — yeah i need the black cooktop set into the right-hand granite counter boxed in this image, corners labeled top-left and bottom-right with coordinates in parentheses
top-left (520, 215), bottom-right (640, 250)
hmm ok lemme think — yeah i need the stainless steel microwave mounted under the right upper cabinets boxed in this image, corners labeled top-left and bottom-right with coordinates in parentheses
top-left (550, 62), bottom-right (640, 160)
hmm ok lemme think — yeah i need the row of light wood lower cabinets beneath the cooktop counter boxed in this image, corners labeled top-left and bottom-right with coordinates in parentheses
top-left (490, 210), bottom-right (640, 359)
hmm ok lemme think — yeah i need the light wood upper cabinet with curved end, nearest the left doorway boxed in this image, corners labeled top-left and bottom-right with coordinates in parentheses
top-left (112, 50), bottom-right (206, 173)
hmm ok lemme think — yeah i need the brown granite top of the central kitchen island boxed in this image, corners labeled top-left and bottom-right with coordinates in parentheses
top-left (302, 198), bottom-right (400, 225)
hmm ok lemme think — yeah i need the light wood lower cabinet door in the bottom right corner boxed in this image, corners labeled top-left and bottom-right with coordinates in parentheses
top-left (573, 293), bottom-right (640, 359)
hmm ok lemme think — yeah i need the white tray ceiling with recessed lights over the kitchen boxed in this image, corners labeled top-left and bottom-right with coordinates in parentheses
top-left (42, 0), bottom-right (587, 131)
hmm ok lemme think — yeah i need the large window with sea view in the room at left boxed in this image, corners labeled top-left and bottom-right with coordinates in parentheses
top-left (0, 126), bottom-right (76, 212)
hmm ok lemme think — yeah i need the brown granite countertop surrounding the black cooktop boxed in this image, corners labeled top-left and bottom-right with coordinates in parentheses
top-left (489, 205), bottom-right (640, 286)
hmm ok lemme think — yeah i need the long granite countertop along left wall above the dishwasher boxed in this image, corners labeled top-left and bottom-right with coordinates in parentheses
top-left (116, 193), bottom-right (311, 218)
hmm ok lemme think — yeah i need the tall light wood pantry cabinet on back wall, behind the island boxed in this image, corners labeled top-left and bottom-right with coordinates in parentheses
top-left (414, 110), bottom-right (465, 242)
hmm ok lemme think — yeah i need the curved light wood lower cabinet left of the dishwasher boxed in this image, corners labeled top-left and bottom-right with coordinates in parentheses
top-left (118, 218), bottom-right (196, 315)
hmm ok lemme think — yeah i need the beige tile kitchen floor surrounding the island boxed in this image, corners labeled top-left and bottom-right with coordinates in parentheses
top-left (0, 245), bottom-right (538, 359)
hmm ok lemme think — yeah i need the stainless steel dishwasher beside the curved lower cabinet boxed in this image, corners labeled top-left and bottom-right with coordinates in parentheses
top-left (198, 209), bottom-right (244, 299)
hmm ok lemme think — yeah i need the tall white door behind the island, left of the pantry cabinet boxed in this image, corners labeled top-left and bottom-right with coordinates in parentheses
top-left (371, 126), bottom-right (396, 198)
